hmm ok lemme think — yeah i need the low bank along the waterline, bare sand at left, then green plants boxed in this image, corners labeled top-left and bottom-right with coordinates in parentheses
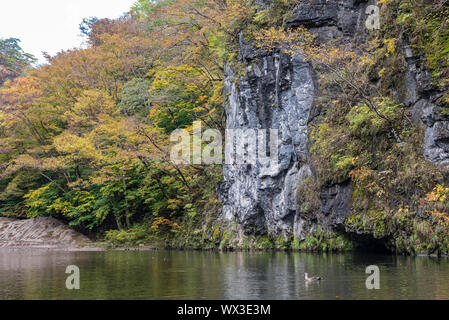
top-left (0, 217), bottom-right (447, 257)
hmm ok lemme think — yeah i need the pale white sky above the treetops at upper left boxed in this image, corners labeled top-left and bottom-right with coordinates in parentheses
top-left (0, 0), bottom-right (136, 63)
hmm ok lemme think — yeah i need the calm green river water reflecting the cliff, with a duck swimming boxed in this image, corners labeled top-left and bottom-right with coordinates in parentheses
top-left (0, 250), bottom-right (449, 300)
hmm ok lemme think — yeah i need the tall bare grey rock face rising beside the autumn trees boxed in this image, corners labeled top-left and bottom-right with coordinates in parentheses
top-left (218, 53), bottom-right (315, 232)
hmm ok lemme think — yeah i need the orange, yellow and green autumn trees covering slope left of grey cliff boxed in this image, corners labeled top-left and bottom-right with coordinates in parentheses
top-left (0, 0), bottom-right (242, 232)
